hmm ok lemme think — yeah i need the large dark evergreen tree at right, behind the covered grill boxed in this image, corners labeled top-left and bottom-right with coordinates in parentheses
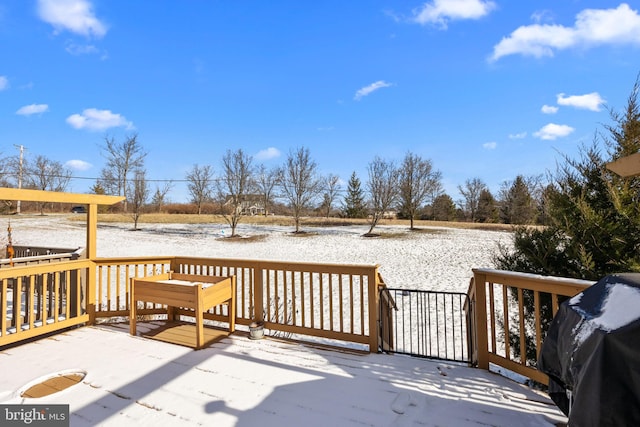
top-left (496, 73), bottom-right (640, 280)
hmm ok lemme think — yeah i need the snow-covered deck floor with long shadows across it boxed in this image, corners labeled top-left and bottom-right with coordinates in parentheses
top-left (0, 322), bottom-right (566, 427)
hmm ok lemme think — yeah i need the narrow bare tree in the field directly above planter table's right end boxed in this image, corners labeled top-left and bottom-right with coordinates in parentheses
top-left (218, 149), bottom-right (253, 237)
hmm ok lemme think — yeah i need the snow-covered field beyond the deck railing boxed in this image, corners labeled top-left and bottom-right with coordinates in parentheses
top-left (5, 215), bottom-right (511, 292)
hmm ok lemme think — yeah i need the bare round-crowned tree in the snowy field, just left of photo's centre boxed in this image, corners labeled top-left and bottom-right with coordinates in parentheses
top-left (278, 147), bottom-right (322, 233)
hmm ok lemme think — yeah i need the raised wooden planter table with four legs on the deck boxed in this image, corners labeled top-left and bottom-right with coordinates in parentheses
top-left (129, 272), bottom-right (236, 348)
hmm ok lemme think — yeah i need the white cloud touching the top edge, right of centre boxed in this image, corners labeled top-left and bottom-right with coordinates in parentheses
top-left (413, 0), bottom-right (496, 29)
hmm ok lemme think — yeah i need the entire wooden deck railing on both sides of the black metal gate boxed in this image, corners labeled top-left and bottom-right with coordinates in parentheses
top-left (0, 251), bottom-right (592, 383)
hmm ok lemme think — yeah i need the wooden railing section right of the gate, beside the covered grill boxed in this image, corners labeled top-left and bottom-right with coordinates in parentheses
top-left (466, 269), bottom-right (593, 384)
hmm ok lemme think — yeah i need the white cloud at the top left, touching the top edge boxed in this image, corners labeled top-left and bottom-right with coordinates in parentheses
top-left (38, 0), bottom-right (107, 38)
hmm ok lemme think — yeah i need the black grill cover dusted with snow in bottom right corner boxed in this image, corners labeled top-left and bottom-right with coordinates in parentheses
top-left (538, 273), bottom-right (640, 427)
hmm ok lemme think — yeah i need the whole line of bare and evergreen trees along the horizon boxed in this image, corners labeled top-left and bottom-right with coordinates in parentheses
top-left (0, 133), bottom-right (544, 234)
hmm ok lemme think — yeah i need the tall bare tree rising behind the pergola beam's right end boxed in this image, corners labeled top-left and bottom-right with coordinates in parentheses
top-left (99, 134), bottom-right (147, 212)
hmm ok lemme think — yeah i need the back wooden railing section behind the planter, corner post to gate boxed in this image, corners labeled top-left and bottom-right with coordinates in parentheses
top-left (95, 257), bottom-right (384, 351)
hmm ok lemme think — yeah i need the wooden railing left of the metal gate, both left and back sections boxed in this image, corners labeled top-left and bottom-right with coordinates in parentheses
top-left (0, 257), bottom-right (384, 351)
